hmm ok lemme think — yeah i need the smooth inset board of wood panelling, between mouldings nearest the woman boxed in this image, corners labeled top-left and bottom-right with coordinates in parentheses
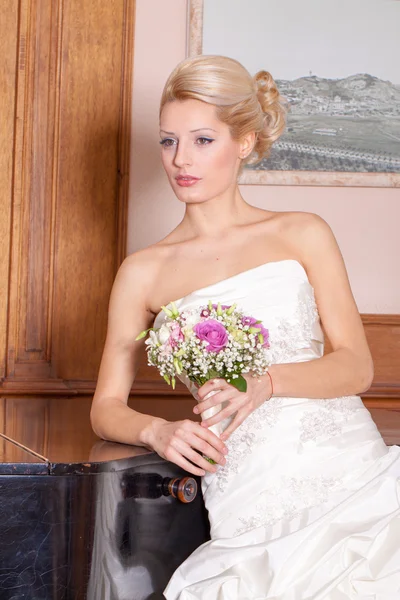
top-left (53, 0), bottom-right (128, 379)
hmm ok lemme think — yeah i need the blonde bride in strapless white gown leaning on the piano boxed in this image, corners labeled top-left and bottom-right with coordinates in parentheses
top-left (91, 56), bottom-right (400, 600)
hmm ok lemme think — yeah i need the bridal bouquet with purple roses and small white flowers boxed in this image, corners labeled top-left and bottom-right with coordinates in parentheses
top-left (136, 300), bottom-right (269, 435)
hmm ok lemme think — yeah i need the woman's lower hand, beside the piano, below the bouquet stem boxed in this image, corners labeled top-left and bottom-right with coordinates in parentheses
top-left (151, 419), bottom-right (228, 475)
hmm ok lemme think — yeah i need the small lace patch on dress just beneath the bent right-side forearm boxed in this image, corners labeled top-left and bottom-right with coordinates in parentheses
top-left (300, 396), bottom-right (359, 442)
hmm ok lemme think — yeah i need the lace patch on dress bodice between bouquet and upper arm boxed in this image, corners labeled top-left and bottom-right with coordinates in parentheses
top-left (268, 286), bottom-right (322, 363)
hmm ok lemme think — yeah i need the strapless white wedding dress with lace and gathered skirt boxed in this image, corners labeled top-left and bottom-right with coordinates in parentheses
top-left (155, 260), bottom-right (400, 600)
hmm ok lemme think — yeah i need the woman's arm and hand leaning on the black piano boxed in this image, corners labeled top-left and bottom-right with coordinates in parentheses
top-left (90, 255), bottom-right (226, 475)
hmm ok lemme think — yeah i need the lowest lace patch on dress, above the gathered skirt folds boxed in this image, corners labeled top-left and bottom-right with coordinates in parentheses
top-left (234, 475), bottom-right (342, 535)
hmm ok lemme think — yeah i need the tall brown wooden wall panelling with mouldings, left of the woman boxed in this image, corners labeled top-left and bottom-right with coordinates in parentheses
top-left (0, 0), bottom-right (135, 393)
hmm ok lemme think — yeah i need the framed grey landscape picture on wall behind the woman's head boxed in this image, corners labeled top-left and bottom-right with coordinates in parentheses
top-left (187, 0), bottom-right (400, 187)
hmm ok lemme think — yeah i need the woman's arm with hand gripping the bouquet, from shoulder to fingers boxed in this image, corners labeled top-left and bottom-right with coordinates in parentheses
top-left (194, 213), bottom-right (373, 440)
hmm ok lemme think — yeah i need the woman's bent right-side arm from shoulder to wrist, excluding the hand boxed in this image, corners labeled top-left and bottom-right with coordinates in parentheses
top-left (269, 214), bottom-right (373, 398)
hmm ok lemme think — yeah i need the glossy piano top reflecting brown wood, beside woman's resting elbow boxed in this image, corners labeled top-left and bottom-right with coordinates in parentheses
top-left (0, 396), bottom-right (153, 475)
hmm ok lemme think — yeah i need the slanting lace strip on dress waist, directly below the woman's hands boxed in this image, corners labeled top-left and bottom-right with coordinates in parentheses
top-left (215, 398), bottom-right (282, 492)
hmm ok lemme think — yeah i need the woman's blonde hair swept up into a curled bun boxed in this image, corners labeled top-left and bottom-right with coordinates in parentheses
top-left (160, 55), bottom-right (286, 163)
